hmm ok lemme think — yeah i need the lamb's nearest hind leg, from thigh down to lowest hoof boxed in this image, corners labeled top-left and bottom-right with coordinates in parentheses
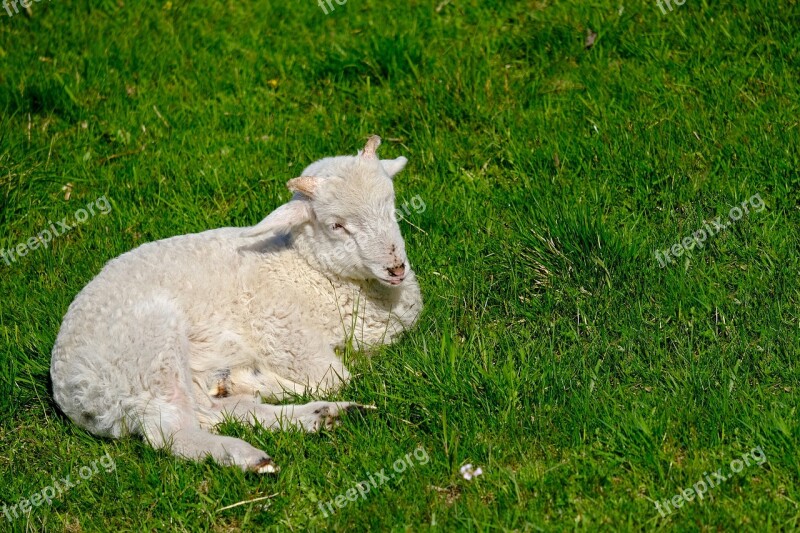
top-left (127, 300), bottom-right (278, 473)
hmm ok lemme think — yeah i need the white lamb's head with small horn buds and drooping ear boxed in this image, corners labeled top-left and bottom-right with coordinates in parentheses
top-left (244, 136), bottom-right (409, 286)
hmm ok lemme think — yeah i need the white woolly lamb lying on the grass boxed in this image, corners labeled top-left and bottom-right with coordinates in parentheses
top-left (50, 136), bottom-right (422, 473)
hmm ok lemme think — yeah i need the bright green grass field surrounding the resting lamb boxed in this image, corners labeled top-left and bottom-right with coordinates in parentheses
top-left (0, 0), bottom-right (800, 531)
